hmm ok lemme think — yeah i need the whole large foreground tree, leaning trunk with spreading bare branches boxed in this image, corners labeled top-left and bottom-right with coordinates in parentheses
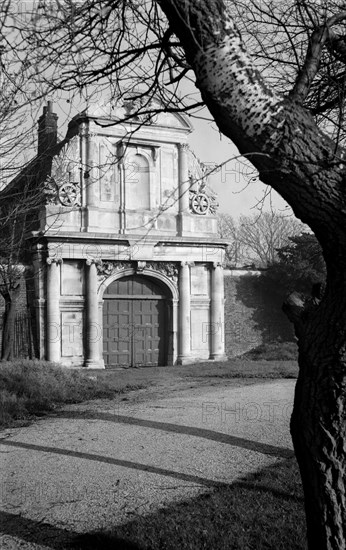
top-left (2, 0), bottom-right (346, 550)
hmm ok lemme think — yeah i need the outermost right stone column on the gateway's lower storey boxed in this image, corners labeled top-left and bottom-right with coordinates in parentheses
top-left (210, 262), bottom-right (225, 360)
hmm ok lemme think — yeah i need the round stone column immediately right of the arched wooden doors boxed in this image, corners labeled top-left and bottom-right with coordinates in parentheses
top-left (178, 262), bottom-right (191, 364)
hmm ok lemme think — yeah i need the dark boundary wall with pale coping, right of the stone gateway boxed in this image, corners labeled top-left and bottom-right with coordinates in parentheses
top-left (224, 269), bottom-right (295, 357)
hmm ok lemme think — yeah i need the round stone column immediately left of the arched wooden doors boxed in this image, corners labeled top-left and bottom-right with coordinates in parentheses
top-left (85, 258), bottom-right (102, 368)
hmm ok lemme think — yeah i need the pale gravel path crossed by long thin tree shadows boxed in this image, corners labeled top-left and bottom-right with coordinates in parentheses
top-left (0, 380), bottom-right (295, 550)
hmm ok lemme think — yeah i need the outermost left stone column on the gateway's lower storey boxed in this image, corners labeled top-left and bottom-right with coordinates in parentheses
top-left (47, 258), bottom-right (62, 363)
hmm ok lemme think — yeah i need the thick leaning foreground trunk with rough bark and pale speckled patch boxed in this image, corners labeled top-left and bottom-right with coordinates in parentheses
top-left (157, 0), bottom-right (346, 550)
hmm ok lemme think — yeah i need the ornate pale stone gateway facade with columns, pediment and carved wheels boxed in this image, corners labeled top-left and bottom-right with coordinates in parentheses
top-left (25, 105), bottom-right (230, 368)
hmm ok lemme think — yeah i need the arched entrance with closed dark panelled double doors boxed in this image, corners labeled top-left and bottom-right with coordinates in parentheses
top-left (103, 275), bottom-right (169, 367)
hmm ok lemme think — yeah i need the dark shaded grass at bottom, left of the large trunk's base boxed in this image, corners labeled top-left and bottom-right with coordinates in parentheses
top-left (72, 458), bottom-right (306, 550)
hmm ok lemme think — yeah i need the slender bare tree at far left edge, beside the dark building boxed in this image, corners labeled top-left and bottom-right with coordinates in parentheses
top-left (0, 0), bottom-right (45, 360)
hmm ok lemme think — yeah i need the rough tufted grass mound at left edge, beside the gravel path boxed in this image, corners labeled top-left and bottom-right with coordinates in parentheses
top-left (0, 359), bottom-right (143, 427)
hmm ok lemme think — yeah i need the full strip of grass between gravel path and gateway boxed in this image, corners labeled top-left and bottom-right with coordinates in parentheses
top-left (0, 359), bottom-right (298, 434)
